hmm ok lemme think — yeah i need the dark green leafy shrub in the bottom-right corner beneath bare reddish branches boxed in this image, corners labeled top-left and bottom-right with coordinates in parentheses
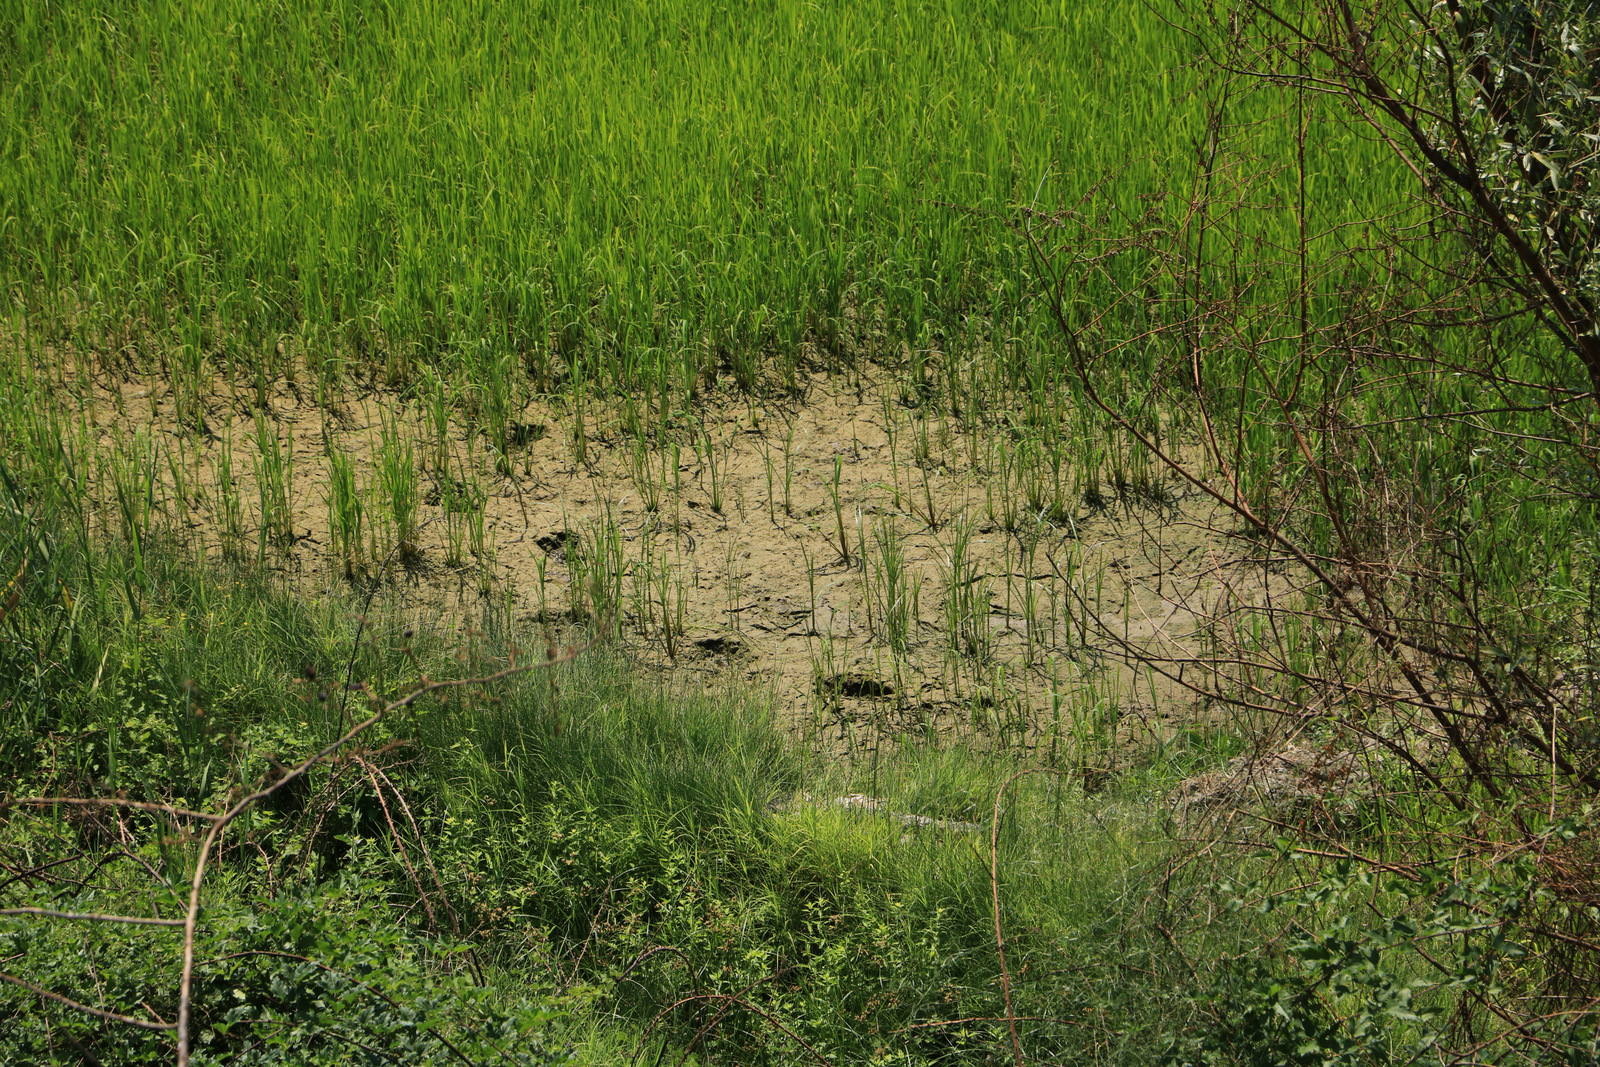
top-left (1166, 844), bottom-right (1600, 1067)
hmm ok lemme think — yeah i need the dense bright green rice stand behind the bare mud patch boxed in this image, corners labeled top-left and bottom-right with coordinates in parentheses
top-left (0, 0), bottom-right (1390, 412)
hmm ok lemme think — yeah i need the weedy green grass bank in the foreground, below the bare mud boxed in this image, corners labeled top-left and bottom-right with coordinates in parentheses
top-left (0, 521), bottom-right (1234, 1062)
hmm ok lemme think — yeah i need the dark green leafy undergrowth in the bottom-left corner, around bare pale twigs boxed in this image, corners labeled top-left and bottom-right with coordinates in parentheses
top-left (0, 877), bottom-right (570, 1067)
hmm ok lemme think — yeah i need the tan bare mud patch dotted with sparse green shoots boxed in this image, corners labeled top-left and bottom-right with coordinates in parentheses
top-left (65, 363), bottom-right (1259, 747)
